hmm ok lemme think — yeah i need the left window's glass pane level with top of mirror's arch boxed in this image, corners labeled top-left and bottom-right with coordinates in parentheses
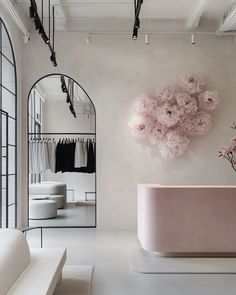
top-left (2, 57), bottom-right (15, 93)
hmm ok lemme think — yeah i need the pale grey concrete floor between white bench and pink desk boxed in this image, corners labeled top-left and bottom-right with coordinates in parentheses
top-left (25, 229), bottom-right (236, 295)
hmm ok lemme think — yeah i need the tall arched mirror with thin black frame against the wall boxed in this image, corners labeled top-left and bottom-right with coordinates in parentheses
top-left (28, 74), bottom-right (96, 227)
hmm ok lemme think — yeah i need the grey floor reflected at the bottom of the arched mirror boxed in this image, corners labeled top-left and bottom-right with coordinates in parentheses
top-left (29, 202), bottom-right (96, 227)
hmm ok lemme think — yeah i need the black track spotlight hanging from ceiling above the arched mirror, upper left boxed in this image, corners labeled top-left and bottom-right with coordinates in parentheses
top-left (29, 0), bottom-right (57, 67)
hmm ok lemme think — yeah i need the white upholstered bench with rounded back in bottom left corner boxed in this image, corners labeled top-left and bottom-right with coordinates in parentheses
top-left (0, 229), bottom-right (66, 295)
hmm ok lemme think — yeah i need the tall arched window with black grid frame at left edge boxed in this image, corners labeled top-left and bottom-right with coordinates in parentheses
top-left (0, 17), bottom-right (17, 228)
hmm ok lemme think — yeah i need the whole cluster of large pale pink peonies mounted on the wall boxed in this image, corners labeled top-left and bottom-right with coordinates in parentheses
top-left (129, 74), bottom-right (219, 159)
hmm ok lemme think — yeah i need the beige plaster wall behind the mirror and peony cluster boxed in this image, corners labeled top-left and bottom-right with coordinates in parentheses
top-left (22, 33), bottom-right (236, 229)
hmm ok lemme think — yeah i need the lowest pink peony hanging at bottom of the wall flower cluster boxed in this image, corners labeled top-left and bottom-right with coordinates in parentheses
top-left (159, 131), bottom-right (189, 160)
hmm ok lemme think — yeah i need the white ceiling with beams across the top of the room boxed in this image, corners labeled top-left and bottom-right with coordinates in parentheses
top-left (14, 0), bottom-right (234, 31)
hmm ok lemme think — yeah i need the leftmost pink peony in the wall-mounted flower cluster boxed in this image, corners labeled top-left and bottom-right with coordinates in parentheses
top-left (128, 116), bottom-right (154, 137)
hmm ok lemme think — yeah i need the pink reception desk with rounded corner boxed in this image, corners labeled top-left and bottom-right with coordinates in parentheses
top-left (138, 184), bottom-right (236, 256)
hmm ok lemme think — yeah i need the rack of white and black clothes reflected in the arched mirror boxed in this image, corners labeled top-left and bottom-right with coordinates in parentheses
top-left (28, 132), bottom-right (96, 173)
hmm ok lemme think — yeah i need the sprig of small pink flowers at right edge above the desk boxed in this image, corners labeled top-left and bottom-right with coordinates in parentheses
top-left (218, 121), bottom-right (236, 171)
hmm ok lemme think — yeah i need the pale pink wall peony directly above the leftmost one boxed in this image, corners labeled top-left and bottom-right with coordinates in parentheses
top-left (134, 95), bottom-right (157, 115)
